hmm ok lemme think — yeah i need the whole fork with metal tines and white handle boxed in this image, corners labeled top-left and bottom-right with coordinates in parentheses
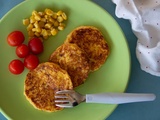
top-left (55, 90), bottom-right (156, 108)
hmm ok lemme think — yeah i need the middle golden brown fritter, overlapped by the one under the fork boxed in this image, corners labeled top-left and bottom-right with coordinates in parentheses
top-left (49, 43), bottom-right (90, 87)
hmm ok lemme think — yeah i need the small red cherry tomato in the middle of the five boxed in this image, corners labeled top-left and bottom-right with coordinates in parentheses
top-left (16, 44), bottom-right (29, 58)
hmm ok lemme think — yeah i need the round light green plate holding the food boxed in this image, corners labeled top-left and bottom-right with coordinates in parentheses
top-left (0, 0), bottom-right (130, 120)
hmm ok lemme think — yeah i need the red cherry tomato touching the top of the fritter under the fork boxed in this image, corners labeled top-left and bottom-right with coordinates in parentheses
top-left (24, 54), bottom-right (39, 70)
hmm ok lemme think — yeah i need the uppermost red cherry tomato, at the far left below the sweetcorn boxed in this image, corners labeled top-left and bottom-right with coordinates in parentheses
top-left (7, 31), bottom-right (25, 46)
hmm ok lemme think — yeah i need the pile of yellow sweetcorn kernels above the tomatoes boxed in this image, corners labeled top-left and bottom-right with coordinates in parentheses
top-left (23, 8), bottom-right (67, 40)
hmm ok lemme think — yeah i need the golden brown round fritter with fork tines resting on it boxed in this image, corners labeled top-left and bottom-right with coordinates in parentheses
top-left (24, 62), bottom-right (73, 112)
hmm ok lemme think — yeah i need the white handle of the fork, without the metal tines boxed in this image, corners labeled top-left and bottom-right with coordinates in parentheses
top-left (86, 93), bottom-right (156, 104)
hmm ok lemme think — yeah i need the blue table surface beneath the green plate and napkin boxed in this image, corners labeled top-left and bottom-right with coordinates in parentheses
top-left (0, 0), bottom-right (160, 120)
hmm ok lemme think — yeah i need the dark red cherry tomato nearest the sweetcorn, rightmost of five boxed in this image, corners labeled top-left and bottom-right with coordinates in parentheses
top-left (28, 38), bottom-right (43, 54)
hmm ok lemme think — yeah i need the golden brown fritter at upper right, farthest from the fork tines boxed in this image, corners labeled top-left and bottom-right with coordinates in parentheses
top-left (65, 26), bottom-right (110, 71)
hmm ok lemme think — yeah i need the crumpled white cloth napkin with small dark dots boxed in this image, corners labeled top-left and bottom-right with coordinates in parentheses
top-left (112, 0), bottom-right (160, 76)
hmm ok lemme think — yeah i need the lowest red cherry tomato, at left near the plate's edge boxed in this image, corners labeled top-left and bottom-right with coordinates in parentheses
top-left (9, 59), bottom-right (24, 74)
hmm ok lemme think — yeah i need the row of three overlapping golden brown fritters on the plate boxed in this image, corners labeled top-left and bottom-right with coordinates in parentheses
top-left (25, 26), bottom-right (109, 112)
